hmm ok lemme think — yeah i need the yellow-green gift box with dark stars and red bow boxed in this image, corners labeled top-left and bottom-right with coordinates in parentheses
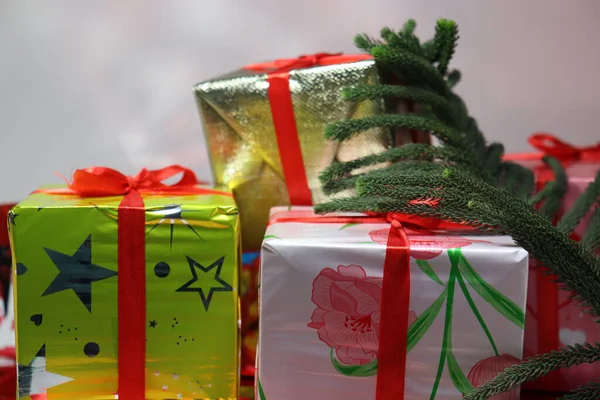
top-left (9, 166), bottom-right (240, 400)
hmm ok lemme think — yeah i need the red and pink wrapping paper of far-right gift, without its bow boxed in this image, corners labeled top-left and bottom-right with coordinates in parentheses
top-left (523, 161), bottom-right (600, 392)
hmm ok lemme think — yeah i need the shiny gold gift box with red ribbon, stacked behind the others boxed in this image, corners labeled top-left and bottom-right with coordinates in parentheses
top-left (194, 54), bottom-right (391, 251)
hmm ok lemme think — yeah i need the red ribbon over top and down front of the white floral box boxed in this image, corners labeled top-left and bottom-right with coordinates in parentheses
top-left (269, 212), bottom-right (468, 400)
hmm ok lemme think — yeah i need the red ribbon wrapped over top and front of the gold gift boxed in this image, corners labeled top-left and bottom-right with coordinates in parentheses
top-left (244, 53), bottom-right (372, 206)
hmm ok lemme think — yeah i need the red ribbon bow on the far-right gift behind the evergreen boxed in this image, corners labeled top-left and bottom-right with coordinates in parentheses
top-left (505, 133), bottom-right (600, 162)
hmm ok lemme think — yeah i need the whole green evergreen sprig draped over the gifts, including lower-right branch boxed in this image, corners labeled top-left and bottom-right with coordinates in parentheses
top-left (316, 20), bottom-right (600, 400)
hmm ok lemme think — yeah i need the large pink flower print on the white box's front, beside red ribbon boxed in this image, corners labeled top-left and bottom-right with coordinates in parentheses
top-left (308, 265), bottom-right (417, 365)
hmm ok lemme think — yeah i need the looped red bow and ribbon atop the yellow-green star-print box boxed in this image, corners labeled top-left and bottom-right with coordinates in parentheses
top-left (34, 165), bottom-right (231, 198)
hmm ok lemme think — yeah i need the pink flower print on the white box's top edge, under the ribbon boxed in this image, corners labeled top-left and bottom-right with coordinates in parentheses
top-left (369, 227), bottom-right (487, 260)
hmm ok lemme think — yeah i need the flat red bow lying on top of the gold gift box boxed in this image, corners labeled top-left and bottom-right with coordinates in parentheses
top-left (244, 53), bottom-right (373, 73)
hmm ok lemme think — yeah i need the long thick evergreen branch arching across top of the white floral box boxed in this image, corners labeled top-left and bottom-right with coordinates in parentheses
top-left (318, 169), bottom-right (600, 316)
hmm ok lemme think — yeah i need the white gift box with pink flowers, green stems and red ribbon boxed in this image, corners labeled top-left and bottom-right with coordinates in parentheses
top-left (257, 208), bottom-right (528, 400)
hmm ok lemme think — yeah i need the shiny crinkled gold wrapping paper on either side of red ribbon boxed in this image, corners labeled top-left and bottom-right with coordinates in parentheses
top-left (195, 61), bottom-right (391, 251)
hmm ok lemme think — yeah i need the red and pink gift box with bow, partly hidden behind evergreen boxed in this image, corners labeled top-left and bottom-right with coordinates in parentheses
top-left (506, 134), bottom-right (600, 392)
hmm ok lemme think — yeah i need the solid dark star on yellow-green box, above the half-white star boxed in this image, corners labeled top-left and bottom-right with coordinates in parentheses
top-left (42, 235), bottom-right (117, 313)
